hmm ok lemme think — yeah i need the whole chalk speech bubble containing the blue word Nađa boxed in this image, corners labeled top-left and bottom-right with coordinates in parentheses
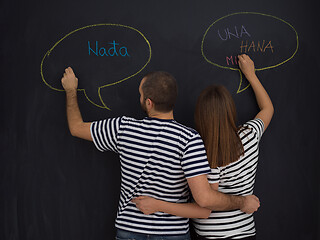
top-left (40, 23), bottom-right (151, 110)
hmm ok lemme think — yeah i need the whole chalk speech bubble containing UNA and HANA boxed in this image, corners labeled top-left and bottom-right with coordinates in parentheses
top-left (201, 12), bottom-right (299, 93)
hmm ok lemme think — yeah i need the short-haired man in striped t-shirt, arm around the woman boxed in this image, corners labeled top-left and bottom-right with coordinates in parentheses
top-left (61, 67), bottom-right (259, 240)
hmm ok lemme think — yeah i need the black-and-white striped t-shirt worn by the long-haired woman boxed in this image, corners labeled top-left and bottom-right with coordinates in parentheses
top-left (193, 119), bottom-right (264, 239)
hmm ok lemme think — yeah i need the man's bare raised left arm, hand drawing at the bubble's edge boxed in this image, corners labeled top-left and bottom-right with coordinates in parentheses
top-left (61, 67), bottom-right (93, 141)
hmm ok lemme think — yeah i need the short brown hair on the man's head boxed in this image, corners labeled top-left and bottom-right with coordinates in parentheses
top-left (141, 71), bottom-right (178, 112)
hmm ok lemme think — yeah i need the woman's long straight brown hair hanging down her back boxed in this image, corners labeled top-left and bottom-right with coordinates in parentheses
top-left (194, 85), bottom-right (244, 168)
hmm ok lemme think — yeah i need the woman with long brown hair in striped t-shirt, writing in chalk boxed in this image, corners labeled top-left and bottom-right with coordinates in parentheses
top-left (134, 54), bottom-right (273, 239)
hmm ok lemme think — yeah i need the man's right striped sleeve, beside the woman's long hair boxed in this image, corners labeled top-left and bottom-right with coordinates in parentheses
top-left (181, 134), bottom-right (210, 178)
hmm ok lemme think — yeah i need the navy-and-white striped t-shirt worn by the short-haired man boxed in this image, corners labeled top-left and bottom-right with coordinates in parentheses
top-left (91, 117), bottom-right (210, 235)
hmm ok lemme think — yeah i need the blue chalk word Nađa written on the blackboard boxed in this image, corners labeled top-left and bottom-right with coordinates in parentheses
top-left (88, 40), bottom-right (130, 57)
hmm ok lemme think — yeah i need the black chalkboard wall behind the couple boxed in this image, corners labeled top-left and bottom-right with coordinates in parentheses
top-left (0, 0), bottom-right (320, 240)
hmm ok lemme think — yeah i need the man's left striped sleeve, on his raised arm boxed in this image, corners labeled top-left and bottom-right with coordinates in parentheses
top-left (90, 118), bottom-right (121, 152)
